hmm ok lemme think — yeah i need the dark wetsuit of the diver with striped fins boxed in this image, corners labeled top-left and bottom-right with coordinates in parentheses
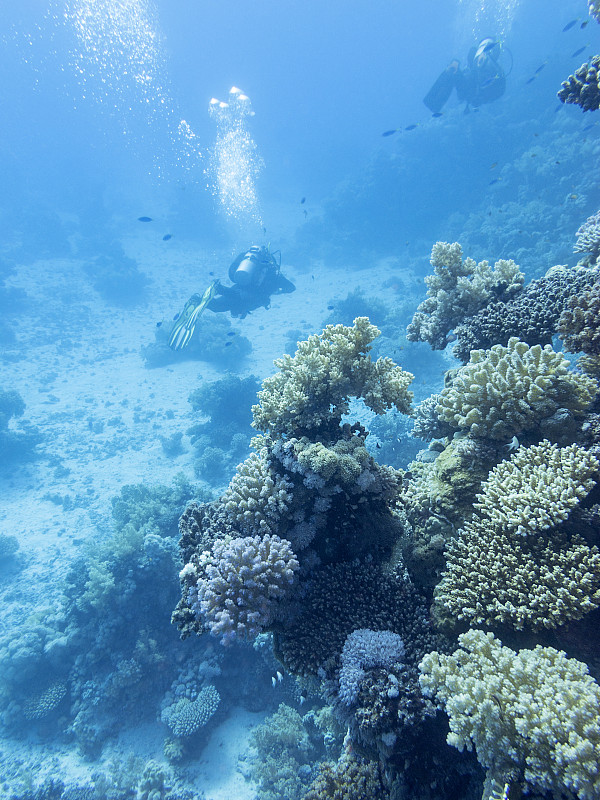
top-left (207, 253), bottom-right (296, 319)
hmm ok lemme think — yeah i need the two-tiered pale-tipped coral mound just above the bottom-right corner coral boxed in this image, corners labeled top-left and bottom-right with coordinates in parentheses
top-left (435, 441), bottom-right (600, 630)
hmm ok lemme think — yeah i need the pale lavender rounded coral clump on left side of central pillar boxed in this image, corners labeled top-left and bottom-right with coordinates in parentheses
top-left (182, 534), bottom-right (299, 644)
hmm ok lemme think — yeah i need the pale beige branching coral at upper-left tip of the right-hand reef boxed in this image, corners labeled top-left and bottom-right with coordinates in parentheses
top-left (406, 242), bottom-right (523, 350)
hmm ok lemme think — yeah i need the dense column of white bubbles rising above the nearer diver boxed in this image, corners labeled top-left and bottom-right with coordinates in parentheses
top-left (207, 86), bottom-right (264, 233)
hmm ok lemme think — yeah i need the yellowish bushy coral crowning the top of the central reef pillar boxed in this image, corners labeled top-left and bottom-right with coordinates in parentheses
top-left (252, 317), bottom-right (414, 437)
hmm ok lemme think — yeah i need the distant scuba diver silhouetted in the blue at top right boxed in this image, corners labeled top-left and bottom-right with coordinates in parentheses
top-left (423, 37), bottom-right (510, 114)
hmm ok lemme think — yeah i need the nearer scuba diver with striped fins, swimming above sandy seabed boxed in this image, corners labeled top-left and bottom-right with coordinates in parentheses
top-left (169, 245), bottom-right (296, 350)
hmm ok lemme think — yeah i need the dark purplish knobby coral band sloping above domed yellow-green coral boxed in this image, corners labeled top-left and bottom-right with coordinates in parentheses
top-left (452, 266), bottom-right (599, 363)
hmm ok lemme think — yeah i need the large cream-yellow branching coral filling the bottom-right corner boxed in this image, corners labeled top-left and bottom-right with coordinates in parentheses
top-left (419, 630), bottom-right (600, 800)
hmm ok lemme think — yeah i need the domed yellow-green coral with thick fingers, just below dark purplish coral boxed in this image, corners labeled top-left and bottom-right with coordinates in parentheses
top-left (436, 337), bottom-right (598, 439)
